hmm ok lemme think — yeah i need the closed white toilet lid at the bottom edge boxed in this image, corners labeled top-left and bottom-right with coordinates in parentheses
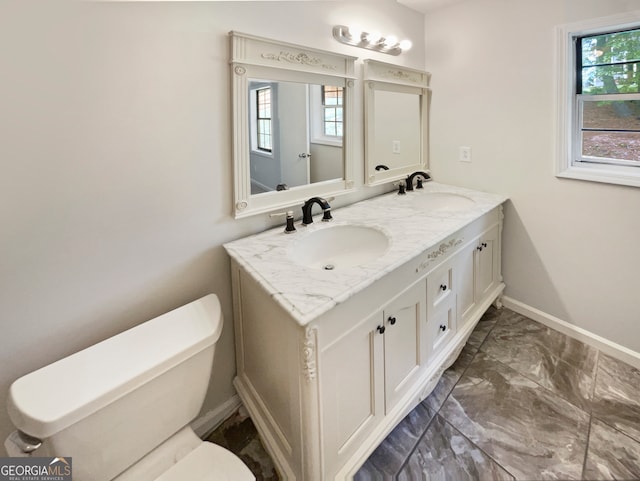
top-left (155, 442), bottom-right (256, 481)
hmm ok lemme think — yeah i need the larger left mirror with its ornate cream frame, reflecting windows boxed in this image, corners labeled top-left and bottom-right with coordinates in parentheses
top-left (229, 32), bottom-right (356, 218)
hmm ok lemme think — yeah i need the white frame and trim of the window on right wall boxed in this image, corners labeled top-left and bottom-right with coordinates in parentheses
top-left (555, 10), bottom-right (640, 187)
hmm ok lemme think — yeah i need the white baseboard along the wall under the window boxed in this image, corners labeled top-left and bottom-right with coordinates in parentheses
top-left (502, 296), bottom-right (640, 369)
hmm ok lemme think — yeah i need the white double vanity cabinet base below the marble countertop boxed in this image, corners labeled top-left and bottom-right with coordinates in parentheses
top-left (231, 201), bottom-right (504, 481)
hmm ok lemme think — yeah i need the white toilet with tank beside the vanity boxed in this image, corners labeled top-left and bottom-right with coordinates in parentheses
top-left (5, 294), bottom-right (255, 481)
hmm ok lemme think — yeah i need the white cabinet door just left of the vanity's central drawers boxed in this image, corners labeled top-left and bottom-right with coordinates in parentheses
top-left (383, 282), bottom-right (426, 412)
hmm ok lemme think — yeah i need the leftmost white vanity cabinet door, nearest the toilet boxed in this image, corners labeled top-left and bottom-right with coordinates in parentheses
top-left (319, 311), bottom-right (384, 466)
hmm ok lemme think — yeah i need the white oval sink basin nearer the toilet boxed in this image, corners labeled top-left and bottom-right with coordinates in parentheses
top-left (288, 225), bottom-right (389, 271)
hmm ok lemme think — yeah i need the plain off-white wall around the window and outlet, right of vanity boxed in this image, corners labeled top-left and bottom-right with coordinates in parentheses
top-left (425, 0), bottom-right (640, 352)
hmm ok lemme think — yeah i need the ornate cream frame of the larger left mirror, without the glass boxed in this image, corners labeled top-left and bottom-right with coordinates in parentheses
top-left (229, 31), bottom-right (356, 218)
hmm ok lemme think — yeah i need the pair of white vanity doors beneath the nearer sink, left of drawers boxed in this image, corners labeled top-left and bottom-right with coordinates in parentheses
top-left (318, 281), bottom-right (426, 472)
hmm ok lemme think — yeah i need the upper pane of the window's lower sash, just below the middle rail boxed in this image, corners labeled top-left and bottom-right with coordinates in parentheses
top-left (582, 100), bottom-right (640, 130)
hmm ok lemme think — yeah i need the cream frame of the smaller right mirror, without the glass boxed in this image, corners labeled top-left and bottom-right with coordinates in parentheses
top-left (364, 59), bottom-right (431, 186)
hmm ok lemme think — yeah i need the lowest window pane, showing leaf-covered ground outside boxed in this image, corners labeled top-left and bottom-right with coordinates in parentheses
top-left (582, 131), bottom-right (640, 163)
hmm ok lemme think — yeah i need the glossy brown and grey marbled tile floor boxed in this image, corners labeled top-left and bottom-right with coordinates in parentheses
top-left (209, 308), bottom-right (640, 481)
